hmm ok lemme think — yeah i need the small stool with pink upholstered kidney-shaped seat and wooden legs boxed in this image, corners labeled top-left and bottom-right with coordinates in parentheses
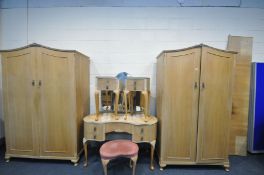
top-left (100, 140), bottom-right (138, 175)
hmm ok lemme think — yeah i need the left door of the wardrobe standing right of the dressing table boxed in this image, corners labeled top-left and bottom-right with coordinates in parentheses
top-left (162, 48), bottom-right (201, 163)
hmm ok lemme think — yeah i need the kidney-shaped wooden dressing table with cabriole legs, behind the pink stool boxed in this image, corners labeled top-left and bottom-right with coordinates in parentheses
top-left (83, 113), bottom-right (157, 170)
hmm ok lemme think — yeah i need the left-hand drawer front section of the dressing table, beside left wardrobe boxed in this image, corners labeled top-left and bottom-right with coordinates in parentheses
top-left (84, 123), bottom-right (105, 141)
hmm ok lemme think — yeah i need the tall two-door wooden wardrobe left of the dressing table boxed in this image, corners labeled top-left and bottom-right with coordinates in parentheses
top-left (0, 44), bottom-right (89, 163)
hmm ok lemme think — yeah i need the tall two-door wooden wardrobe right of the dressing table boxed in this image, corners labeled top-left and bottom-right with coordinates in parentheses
top-left (157, 44), bottom-right (236, 170)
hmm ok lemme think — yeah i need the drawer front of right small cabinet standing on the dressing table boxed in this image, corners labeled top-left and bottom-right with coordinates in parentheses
top-left (126, 77), bottom-right (150, 91)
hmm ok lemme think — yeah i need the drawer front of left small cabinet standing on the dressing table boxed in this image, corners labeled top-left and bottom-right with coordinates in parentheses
top-left (96, 77), bottom-right (119, 91)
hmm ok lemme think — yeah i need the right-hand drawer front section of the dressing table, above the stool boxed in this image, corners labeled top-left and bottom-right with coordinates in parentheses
top-left (132, 124), bottom-right (157, 142)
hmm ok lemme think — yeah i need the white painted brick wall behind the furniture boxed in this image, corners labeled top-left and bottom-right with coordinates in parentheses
top-left (0, 7), bottom-right (264, 139)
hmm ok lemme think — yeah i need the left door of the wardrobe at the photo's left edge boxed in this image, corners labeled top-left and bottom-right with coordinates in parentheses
top-left (2, 48), bottom-right (39, 157)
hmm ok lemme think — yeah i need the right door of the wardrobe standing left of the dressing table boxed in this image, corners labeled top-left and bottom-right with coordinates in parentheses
top-left (37, 48), bottom-right (77, 158)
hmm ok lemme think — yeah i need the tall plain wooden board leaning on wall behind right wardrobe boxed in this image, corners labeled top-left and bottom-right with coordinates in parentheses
top-left (227, 35), bottom-right (253, 155)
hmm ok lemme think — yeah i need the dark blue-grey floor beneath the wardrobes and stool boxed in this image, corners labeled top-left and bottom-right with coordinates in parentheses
top-left (0, 144), bottom-right (264, 175)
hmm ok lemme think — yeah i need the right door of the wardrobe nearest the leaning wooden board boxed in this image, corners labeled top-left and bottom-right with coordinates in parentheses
top-left (197, 47), bottom-right (234, 163)
